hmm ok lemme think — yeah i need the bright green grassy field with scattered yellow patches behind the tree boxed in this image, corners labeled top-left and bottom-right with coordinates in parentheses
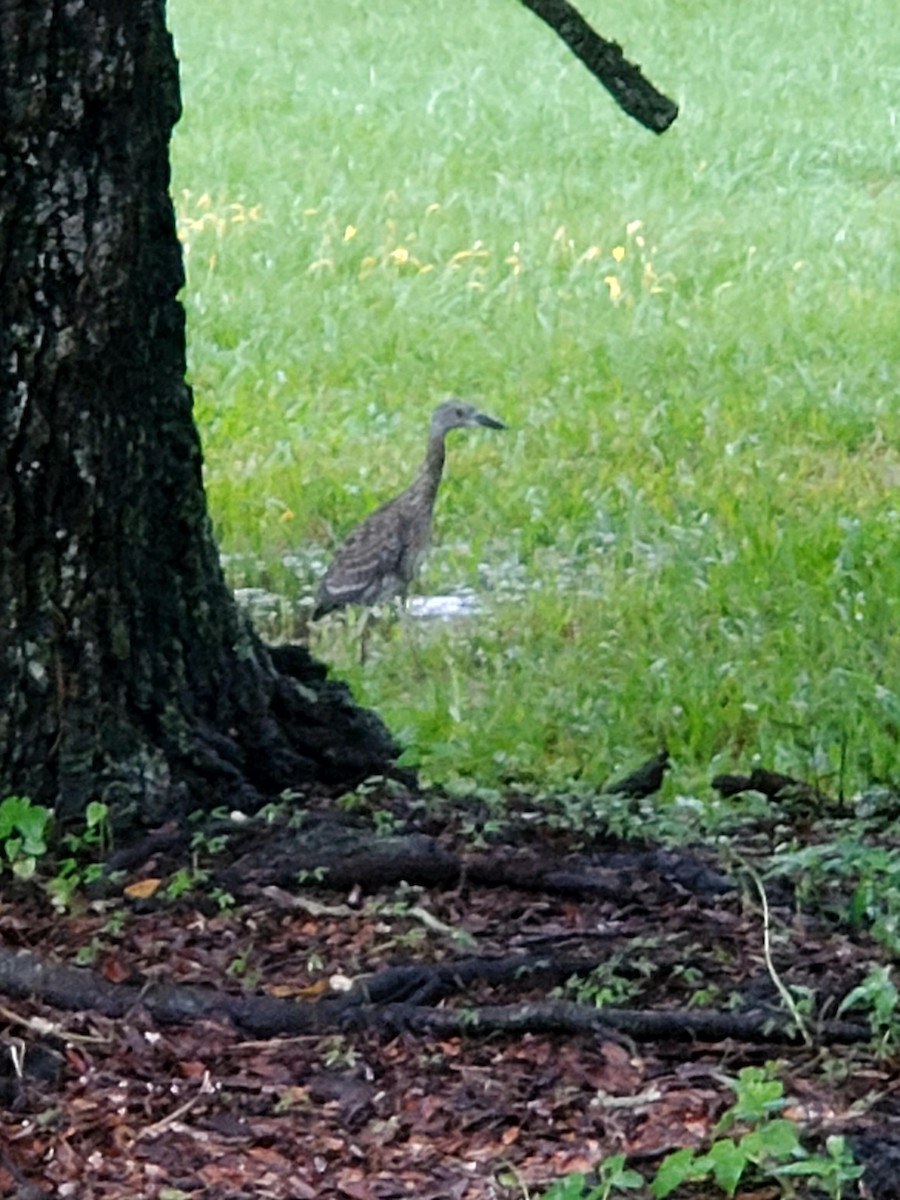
top-left (170, 0), bottom-right (900, 833)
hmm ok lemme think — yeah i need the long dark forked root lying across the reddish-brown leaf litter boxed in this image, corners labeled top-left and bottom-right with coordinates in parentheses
top-left (0, 949), bottom-right (871, 1045)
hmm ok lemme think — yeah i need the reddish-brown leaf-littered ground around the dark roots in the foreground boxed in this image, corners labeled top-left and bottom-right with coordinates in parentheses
top-left (0, 796), bottom-right (900, 1200)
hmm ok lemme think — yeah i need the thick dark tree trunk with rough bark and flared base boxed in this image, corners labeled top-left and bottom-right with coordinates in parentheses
top-left (0, 0), bottom-right (396, 827)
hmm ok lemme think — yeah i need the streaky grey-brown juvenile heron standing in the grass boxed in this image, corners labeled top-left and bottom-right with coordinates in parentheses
top-left (312, 400), bottom-right (506, 620)
